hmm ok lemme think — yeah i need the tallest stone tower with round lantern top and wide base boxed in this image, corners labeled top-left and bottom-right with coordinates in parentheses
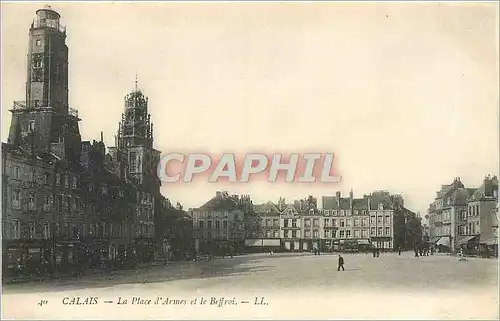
top-left (8, 7), bottom-right (81, 163)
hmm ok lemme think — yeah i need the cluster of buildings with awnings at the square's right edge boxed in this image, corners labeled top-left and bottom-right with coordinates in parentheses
top-left (428, 175), bottom-right (498, 255)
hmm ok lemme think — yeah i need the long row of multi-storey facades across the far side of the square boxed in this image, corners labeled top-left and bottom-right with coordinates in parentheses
top-left (189, 191), bottom-right (421, 251)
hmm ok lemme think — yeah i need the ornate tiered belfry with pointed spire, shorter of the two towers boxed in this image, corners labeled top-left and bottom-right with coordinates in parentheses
top-left (115, 78), bottom-right (160, 193)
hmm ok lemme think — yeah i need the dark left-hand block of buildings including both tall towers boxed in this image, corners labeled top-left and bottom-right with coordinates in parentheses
top-left (2, 8), bottom-right (171, 267)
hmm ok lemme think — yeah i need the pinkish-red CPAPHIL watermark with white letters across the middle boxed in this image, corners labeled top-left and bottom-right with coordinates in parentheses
top-left (157, 153), bottom-right (341, 183)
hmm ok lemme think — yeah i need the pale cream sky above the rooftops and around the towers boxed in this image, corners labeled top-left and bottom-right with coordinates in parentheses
top-left (1, 2), bottom-right (499, 214)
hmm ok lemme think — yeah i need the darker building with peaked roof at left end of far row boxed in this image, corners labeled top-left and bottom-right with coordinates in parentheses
top-left (189, 191), bottom-right (253, 252)
